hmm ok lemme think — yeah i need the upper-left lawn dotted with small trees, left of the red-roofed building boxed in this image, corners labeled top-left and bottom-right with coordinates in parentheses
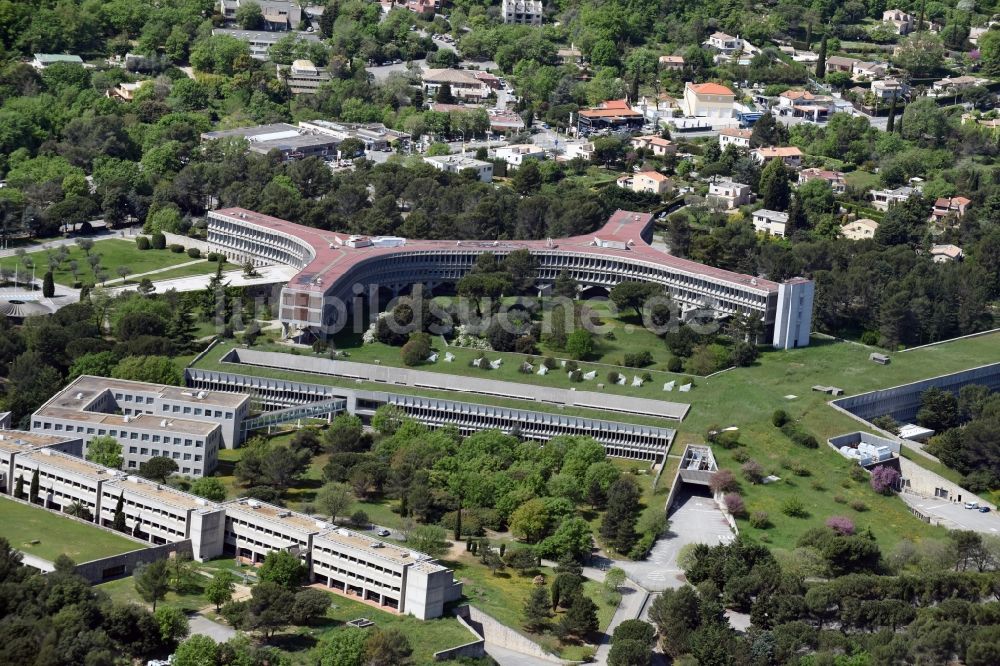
top-left (0, 238), bottom-right (199, 286)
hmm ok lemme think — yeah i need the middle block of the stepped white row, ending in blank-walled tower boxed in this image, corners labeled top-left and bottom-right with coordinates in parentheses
top-left (95, 474), bottom-right (226, 561)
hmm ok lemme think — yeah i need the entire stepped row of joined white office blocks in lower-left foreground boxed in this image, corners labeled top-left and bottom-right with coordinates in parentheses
top-left (0, 431), bottom-right (462, 620)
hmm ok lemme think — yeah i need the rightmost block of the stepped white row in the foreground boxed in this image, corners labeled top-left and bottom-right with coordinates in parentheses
top-left (312, 528), bottom-right (462, 620)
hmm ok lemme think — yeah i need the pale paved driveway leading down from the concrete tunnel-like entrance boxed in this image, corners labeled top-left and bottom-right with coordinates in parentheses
top-left (618, 489), bottom-right (733, 592)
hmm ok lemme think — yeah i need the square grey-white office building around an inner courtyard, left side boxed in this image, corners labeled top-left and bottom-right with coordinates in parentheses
top-left (31, 375), bottom-right (250, 477)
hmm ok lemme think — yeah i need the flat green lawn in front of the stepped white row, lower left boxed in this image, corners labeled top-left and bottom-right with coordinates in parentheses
top-left (0, 496), bottom-right (143, 564)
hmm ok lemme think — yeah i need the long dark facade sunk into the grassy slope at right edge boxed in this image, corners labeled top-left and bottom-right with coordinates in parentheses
top-left (831, 363), bottom-right (1000, 423)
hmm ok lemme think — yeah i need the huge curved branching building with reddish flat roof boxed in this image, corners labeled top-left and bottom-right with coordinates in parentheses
top-left (208, 208), bottom-right (814, 349)
